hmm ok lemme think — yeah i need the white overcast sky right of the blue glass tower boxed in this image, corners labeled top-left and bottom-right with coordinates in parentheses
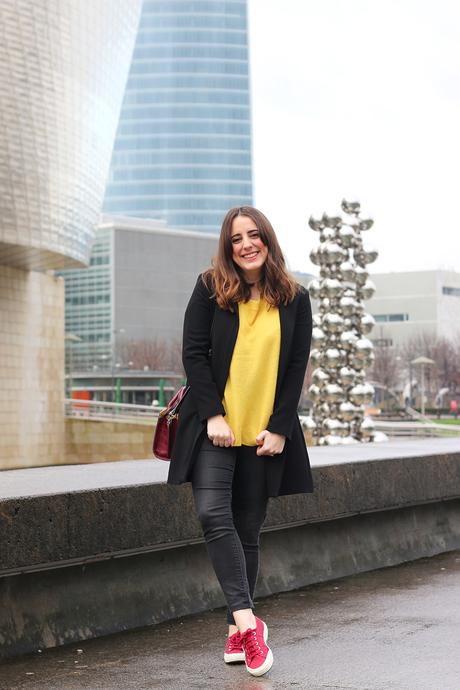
top-left (249, 0), bottom-right (460, 273)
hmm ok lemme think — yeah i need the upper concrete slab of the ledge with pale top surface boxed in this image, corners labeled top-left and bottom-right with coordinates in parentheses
top-left (0, 439), bottom-right (460, 576)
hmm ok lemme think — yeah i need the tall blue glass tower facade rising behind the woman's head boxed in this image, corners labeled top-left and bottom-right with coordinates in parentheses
top-left (104, 0), bottom-right (252, 232)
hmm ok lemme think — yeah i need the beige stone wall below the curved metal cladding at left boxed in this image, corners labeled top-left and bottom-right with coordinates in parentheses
top-left (0, 266), bottom-right (64, 469)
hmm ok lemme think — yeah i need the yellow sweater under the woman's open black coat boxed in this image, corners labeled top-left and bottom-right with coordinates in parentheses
top-left (222, 297), bottom-right (281, 446)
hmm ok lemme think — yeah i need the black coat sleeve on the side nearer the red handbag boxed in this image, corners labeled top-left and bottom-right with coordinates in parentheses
top-left (182, 274), bottom-right (225, 422)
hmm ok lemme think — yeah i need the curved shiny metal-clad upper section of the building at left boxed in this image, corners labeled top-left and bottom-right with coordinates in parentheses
top-left (0, 0), bottom-right (141, 270)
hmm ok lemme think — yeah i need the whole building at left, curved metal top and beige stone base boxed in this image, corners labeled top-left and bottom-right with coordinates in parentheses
top-left (0, 0), bottom-right (141, 469)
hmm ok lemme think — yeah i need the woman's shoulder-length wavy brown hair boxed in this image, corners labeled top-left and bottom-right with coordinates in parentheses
top-left (201, 206), bottom-right (299, 312)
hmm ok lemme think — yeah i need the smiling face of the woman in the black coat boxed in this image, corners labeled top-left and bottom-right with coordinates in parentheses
top-left (231, 216), bottom-right (268, 282)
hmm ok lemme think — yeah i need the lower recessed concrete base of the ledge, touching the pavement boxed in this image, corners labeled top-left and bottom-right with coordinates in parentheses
top-left (0, 500), bottom-right (460, 658)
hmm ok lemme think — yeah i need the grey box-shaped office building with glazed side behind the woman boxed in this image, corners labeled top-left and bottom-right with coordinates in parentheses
top-left (63, 215), bottom-right (218, 371)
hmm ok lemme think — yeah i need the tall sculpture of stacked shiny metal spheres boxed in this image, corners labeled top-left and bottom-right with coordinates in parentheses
top-left (306, 200), bottom-right (378, 445)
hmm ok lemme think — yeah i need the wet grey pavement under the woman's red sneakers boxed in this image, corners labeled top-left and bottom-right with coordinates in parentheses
top-left (0, 551), bottom-right (460, 690)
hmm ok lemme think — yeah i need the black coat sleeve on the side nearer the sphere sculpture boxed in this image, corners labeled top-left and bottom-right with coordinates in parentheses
top-left (267, 288), bottom-right (313, 439)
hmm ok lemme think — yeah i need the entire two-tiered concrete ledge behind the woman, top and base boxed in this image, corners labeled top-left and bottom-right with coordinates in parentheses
top-left (0, 439), bottom-right (460, 656)
